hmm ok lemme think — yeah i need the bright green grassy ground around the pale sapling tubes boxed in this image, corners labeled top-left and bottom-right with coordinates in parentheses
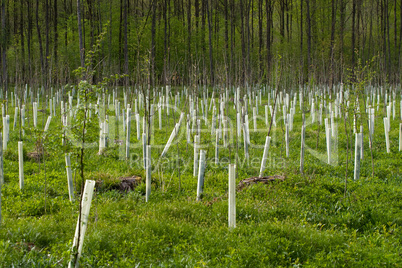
top-left (0, 89), bottom-right (402, 267)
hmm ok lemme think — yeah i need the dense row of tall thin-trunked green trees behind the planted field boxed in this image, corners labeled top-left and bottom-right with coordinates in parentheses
top-left (0, 0), bottom-right (402, 88)
